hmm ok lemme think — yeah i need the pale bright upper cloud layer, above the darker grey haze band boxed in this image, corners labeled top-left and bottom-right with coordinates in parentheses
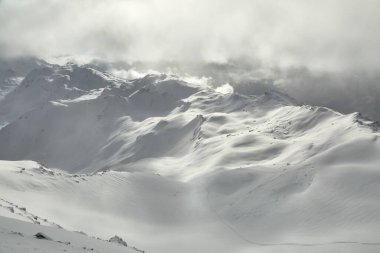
top-left (0, 0), bottom-right (380, 69)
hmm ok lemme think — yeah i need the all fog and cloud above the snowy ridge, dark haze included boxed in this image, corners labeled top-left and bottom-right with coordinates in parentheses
top-left (0, 0), bottom-right (380, 119)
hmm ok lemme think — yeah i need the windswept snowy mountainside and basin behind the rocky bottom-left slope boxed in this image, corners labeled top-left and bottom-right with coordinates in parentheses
top-left (0, 65), bottom-right (380, 253)
